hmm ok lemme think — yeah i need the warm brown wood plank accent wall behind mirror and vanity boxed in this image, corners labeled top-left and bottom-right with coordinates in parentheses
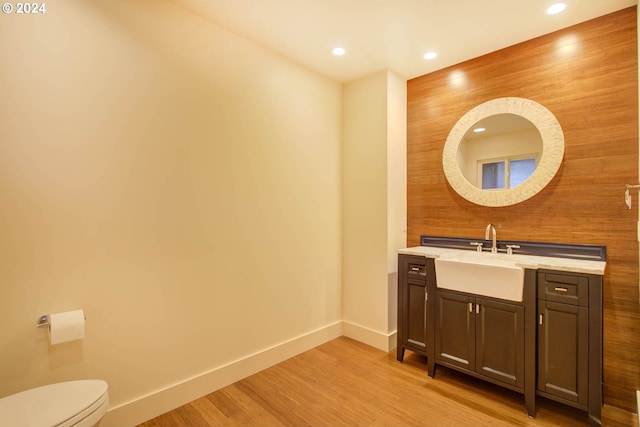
top-left (407, 6), bottom-right (640, 412)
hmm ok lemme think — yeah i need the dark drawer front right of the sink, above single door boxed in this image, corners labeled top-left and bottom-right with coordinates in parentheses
top-left (538, 271), bottom-right (589, 307)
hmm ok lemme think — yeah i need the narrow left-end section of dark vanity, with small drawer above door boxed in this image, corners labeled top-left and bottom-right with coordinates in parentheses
top-left (396, 255), bottom-right (435, 372)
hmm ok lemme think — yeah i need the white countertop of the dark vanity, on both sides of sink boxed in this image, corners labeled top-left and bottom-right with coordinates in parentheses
top-left (398, 246), bottom-right (607, 275)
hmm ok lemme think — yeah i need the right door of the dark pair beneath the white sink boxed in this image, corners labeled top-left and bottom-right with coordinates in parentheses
top-left (475, 298), bottom-right (524, 388)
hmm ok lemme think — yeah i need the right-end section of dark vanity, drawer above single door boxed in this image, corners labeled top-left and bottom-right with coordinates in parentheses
top-left (536, 270), bottom-right (603, 425)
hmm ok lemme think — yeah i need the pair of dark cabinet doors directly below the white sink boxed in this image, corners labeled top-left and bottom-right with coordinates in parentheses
top-left (435, 290), bottom-right (525, 390)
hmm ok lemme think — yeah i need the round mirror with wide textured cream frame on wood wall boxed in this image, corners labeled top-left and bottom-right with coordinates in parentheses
top-left (442, 98), bottom-right (564, 206)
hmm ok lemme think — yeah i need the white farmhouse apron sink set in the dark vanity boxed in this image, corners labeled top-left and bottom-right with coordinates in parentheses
top-left (435, 252), bottom-right (524, 301)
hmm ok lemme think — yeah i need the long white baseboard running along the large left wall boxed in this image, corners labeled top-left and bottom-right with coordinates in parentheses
top-left (100, 321), bottom-right (344, 427)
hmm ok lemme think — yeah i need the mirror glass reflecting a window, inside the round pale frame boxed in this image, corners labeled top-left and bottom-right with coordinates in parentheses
top-left (458, 113), bottom-right (542, 190)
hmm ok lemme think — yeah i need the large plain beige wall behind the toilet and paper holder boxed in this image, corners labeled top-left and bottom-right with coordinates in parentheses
top-left (0, 0), bottom-right (344, 421)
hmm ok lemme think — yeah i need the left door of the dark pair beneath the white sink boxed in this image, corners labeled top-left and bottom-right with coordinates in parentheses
top-left (435, 291), bottom-right (476, 370)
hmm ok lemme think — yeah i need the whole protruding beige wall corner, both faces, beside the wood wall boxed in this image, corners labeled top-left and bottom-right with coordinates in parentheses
top-left (342, 71), bottom-right (406, 350)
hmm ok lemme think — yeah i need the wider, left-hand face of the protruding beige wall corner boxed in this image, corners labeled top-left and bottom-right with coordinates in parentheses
top-left (342, 71), bottom-right (387, 346)
